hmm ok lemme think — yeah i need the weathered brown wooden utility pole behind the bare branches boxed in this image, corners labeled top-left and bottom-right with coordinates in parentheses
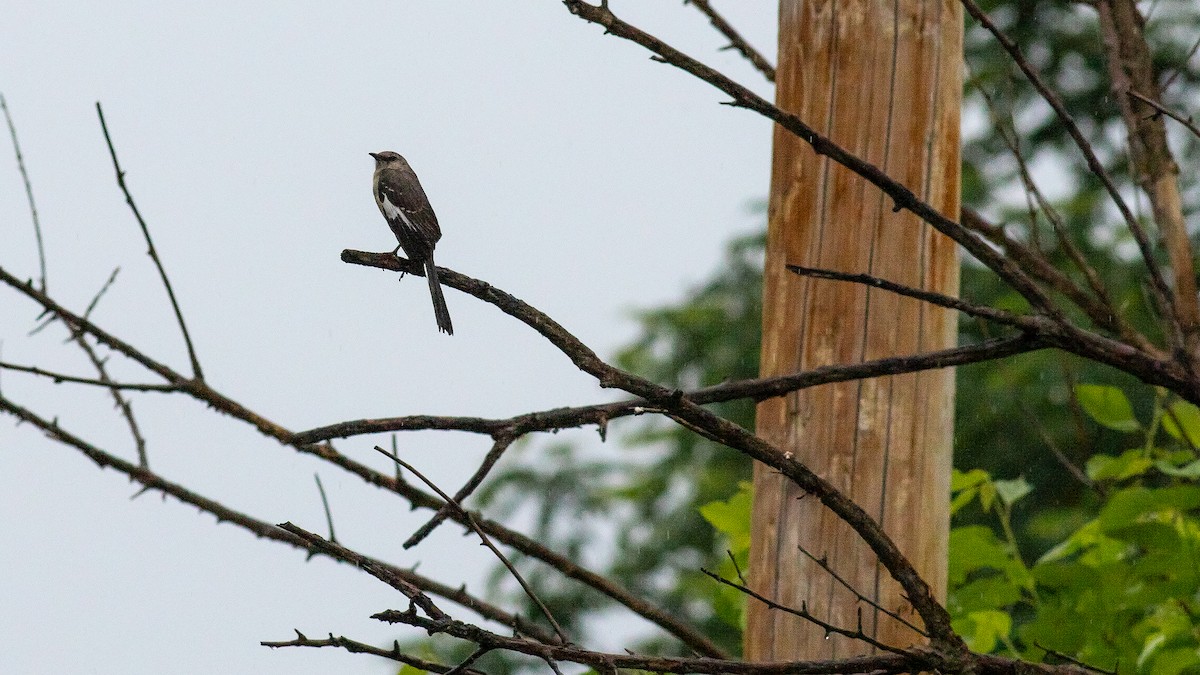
top-left (745, 0), bottom-right (962, 661)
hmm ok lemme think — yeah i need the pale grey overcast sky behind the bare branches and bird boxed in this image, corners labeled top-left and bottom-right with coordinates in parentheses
top-left (0, 0), bottom-right (775, 675)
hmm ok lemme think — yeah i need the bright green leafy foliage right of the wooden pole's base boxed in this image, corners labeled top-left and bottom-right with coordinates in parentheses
top-left (948, 384), bottom-right (1200, 675)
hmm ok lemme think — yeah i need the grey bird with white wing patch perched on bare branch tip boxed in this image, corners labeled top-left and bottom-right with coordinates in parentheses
top-left (368, 150), bottom-right (454, 335)
